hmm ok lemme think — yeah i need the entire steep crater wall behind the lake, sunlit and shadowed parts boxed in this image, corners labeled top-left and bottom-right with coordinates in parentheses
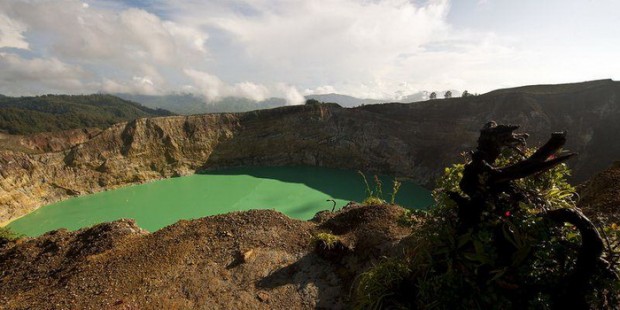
top-left (0, 81), bottom-right (620, 221)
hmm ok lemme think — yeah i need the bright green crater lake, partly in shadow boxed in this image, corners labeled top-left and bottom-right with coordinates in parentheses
top-left (8, 167), bottom-right (432, 236)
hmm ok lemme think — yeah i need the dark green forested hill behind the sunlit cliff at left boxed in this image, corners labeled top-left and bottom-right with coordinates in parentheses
top-left (0, 94), bottom-right (174, 134)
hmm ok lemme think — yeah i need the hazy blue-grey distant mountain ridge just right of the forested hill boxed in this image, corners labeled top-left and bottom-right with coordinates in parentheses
top-left (115, 94), bottom-right (286, 115)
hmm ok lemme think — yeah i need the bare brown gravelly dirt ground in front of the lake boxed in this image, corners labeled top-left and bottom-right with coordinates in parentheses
top-left (0, 204), bottom-right (410, 309)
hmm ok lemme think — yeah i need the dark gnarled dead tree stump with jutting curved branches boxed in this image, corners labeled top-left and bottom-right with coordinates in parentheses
top-left (449, 122), bottom-right (605, 309)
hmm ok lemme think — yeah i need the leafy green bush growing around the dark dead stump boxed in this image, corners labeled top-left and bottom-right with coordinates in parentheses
top-left (353, 151), bottom-right (620, 309)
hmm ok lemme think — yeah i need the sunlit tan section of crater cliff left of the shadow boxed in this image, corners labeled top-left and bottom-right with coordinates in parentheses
top-left (0, 115), bottom-right (238, 221)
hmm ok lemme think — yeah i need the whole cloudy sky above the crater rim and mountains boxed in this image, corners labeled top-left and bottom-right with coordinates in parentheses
top-left (0, 0), bottom-right (620, 104)
